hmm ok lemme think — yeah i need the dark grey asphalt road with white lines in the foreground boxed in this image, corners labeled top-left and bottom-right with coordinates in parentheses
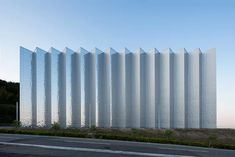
top-left (0, 134), bottom-right (235, 157)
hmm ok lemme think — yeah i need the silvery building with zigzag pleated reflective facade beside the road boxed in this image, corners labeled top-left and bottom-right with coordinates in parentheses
top-left (20, 47), bottom-right (216, 128)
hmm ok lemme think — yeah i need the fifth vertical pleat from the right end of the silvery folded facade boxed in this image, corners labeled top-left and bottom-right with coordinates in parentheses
top-left (140, 50), bottom-right (155, 128)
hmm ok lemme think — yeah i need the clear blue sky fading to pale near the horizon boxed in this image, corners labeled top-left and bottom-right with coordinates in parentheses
top-left (0, 0), bottom-right (235, 128)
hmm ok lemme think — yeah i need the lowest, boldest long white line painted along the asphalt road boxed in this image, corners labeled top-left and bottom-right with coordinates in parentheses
top-left (0, 142), bottom-right (193, 157)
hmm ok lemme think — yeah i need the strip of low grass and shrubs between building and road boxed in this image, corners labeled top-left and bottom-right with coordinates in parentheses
top-left (0, 126), bottom-right (235, 149)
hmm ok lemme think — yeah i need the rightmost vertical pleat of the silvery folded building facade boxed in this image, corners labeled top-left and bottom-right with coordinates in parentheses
top-left (200, 49), bottom-right (216, 128)
